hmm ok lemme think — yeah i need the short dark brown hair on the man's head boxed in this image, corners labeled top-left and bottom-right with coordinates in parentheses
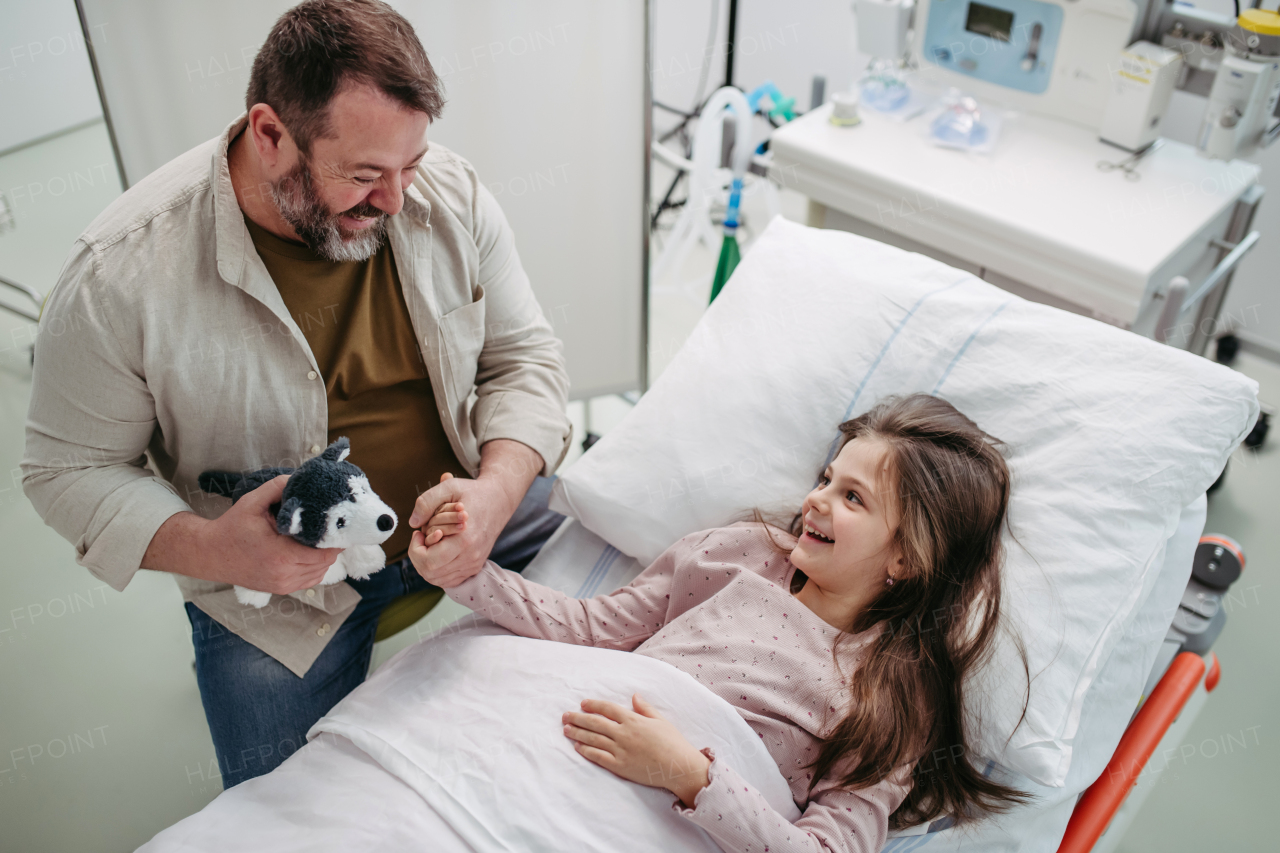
top-left (244, 0), bottom-right (444, 154)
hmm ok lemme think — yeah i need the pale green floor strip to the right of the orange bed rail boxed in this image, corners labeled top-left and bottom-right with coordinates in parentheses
top-left (1119, 353), bottom-right (1280, 853)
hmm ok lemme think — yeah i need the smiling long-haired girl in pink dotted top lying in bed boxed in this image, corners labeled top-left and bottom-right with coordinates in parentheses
top-left (408, 394), bottom-right (1024, 853)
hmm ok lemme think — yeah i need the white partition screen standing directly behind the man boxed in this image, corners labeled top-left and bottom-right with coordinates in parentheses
top-left (73, 0), bottom-right (648, 397)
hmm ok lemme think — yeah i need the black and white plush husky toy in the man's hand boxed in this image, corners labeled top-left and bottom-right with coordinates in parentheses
top-left (197, 437), bottom-right (397, 607)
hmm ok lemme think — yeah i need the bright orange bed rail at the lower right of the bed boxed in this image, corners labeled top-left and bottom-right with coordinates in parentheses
top-left (1057, 652), bottom-right (1219, 853)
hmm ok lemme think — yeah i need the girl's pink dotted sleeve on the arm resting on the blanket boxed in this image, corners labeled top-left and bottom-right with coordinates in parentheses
top-left (672, 749), bottom-right (910, 853)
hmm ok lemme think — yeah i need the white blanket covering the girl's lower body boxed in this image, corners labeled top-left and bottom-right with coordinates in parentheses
top-left (141, 619), bottom-right (800, 853)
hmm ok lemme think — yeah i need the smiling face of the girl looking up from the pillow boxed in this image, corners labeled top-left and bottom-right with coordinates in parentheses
top-left (791, 438), bottom-right (902, 598)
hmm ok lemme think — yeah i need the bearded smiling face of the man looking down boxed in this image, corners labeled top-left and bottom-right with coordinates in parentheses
top-left (270, 83), bottom-right (429, 261)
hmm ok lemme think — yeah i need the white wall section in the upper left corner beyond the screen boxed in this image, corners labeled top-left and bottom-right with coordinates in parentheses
top-left (0, 0), bottom-right (102, 151)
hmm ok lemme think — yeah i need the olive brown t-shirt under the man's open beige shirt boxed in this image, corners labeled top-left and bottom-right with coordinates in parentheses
top-left (244, 216), bottom-right (468, 562)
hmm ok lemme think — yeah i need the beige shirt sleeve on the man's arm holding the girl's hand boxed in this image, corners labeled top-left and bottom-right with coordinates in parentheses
top-left (472, 181), bottom-right (572, 475)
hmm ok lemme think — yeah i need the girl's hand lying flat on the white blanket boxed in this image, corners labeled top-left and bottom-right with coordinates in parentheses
top-left (562, 693), bottom-right (712, 808)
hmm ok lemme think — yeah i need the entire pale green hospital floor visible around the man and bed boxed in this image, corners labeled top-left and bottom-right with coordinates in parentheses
top-left (0, 136), bottom-right (1280, 853)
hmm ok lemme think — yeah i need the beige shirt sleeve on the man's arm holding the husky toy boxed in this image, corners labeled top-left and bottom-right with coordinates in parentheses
top-left (22, 236), bottom-right (191, 589)
